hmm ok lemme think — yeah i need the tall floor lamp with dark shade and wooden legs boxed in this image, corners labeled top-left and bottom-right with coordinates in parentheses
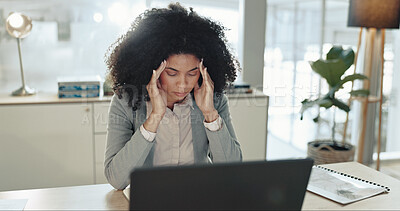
top-left (347, 0), bottom-right (400, 170)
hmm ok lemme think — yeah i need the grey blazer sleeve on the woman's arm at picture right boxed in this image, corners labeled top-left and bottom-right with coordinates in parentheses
top-left (206, 95), bottom-right (242, 163)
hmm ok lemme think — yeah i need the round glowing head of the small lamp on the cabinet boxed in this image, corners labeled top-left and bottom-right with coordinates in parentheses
top-left (6, 12), bottom-right (32, 38)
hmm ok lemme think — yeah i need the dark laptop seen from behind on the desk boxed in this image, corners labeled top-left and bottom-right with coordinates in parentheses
top-left (129, 159), bottom-right (313, 210)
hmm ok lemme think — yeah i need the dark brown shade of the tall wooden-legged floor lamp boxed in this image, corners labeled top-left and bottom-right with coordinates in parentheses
top-left (347, 0), bottom-right (400, 29)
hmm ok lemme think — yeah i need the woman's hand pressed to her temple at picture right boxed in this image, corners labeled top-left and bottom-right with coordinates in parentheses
top-left (194, 60), bottom-right (218, 122)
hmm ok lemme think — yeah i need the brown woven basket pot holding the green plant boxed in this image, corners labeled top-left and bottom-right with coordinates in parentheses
top-left (307, 140), bottom-right (355, 165)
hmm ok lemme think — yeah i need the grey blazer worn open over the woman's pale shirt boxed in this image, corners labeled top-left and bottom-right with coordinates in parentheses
top-left (104, 94), bottom-right (242, 189)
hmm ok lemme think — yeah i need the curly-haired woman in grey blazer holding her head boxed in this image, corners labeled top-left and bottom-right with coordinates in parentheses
top-left (104, 3), bottom-right (242, 189)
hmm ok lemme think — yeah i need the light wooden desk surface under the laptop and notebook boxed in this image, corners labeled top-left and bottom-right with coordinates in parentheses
top-left (0, 162), bottom-right (400, 210)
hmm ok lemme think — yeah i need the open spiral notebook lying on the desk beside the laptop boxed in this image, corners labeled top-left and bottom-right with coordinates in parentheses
top-left (307, 166), bottom-right (390, 204)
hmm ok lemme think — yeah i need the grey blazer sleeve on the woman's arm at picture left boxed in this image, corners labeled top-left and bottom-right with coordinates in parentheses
top-left (104, 95), bottom-right (153, 189)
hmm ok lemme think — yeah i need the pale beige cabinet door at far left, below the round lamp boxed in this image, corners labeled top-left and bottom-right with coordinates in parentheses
top-left (0, 103), bottom-right (94, 191)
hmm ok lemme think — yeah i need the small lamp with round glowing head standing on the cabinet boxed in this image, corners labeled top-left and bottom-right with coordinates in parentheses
top-left (6, 12), bottom-right (36, 96)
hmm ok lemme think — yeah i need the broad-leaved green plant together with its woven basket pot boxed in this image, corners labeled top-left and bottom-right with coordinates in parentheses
top-left (300, 46), bottom-right (369, 164)
